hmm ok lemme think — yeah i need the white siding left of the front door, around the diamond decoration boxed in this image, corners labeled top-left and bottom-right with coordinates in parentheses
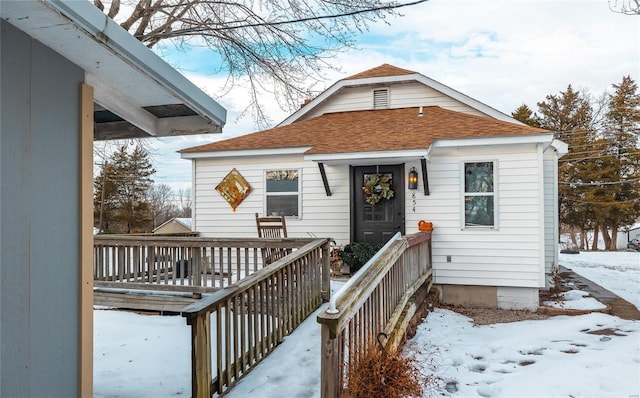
top-left (193, 156), bottom-right (349, 244)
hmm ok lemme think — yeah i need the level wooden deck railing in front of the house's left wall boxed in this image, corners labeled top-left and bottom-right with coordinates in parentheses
top-left (94, 235), bottom-right (324, 311)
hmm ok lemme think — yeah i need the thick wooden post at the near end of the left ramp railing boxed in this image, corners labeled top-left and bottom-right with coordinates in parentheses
top-left (188, 312), bottom-right (212, 398)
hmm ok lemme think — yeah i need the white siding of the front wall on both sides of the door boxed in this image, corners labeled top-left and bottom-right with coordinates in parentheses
top-left (194, 145), bottom-right (549, 288)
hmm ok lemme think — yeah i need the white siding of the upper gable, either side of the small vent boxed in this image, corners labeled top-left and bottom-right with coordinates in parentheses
top-left (305, 83), bottom-right (486, 119)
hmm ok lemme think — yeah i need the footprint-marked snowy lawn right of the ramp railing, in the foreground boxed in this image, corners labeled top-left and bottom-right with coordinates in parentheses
top-left (412, 309), bottom-right (640, 398)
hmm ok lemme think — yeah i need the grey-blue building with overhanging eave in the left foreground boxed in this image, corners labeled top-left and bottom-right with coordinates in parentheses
top-left (0, 0), bottom-right (226, 397)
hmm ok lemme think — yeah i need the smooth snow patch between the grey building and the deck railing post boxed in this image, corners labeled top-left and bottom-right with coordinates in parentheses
top-left (93, 310), bottom-right (191, 398)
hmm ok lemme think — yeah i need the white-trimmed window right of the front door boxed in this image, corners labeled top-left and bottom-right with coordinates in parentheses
top-left (463, 162), bottom-right (496, 227)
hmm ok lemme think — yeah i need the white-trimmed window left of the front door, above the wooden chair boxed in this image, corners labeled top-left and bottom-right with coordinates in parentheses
top-left (265, 169), bottom-right (300, 217)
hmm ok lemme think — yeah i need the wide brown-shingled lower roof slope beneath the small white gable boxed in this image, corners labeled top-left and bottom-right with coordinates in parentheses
top-left (180, 106), bottom-right (547, 158)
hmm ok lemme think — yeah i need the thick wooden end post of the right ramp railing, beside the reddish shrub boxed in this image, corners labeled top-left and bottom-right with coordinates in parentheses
top-left (320, 324), bottom-right (342, 398)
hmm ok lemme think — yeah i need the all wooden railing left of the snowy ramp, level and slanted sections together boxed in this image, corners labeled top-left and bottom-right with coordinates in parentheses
top-left (93, 235), bottom-right (330, 397)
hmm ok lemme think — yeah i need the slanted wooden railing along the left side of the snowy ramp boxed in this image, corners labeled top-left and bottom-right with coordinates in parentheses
top-left (182, 239), bottom-right (330, 398)
